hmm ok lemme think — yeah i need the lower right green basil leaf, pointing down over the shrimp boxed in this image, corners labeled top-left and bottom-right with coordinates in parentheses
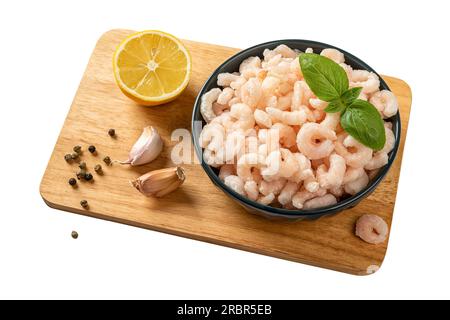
top-left (341, 99), bottom-right (386, 150)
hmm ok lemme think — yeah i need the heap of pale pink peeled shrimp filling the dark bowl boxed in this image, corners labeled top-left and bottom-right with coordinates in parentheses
top-left (199, 45), bottom-right (398, 209)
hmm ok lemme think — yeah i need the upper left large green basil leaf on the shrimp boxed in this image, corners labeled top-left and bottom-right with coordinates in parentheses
top-left (299, 53), bottom-right (348, 102)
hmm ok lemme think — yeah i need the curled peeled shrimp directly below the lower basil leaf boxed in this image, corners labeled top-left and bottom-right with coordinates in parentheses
top-left (334, 133), bottom-right (373, 168)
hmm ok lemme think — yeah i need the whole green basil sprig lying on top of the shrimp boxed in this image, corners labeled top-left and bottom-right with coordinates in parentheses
top-left (299, 53), bottom-right (386, 150)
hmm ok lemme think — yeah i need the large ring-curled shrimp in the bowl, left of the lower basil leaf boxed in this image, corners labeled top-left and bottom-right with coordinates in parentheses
top-left (297, 122), bottom-right (336, 159)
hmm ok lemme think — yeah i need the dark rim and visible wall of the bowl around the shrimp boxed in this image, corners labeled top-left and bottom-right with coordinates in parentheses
top-left (191, 39), bottom-right (401, 218)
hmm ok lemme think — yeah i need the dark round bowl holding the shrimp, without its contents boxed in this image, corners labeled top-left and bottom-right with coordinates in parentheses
top-left (192, 39), bottom-right (401, 220)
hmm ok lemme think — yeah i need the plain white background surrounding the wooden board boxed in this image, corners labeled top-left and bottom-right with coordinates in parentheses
top-left (0, 0), bottom-right (450, 299)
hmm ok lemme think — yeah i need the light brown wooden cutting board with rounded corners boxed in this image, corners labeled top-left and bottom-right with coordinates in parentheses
top-left (40, 30), bottom-right (411, 275)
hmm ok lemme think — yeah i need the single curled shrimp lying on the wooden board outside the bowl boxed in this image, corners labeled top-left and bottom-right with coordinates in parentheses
top-left (355, 214), bottom-right (389, 244)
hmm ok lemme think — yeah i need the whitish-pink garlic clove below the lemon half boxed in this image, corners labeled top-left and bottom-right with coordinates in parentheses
top-left (120, 126), bottom-right (163, 166)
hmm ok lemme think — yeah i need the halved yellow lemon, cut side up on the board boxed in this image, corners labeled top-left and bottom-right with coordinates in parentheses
top-left (113, 30), bottom-right (192, 106)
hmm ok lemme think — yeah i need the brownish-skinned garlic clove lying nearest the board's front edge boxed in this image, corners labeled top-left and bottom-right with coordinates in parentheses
top-left (131, 167), bottom-right (186, 198)
